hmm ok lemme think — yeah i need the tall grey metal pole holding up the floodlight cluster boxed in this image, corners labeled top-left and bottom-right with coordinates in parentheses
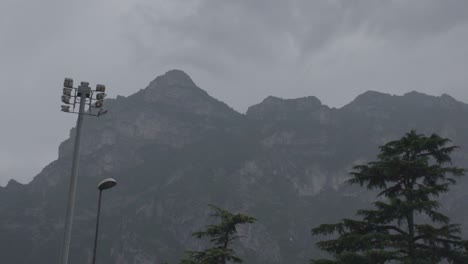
top-left (60, 87), bottom-right (86, 264)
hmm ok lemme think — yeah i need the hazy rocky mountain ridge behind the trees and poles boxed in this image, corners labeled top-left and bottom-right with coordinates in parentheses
top-left (0, 70), bottom-right (468, 264)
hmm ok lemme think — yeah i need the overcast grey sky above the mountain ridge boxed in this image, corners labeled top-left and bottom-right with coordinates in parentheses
top-left (0, 0), bottom-right (468, 186)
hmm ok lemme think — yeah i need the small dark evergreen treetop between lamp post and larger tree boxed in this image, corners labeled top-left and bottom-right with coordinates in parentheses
top-left (180, 205), bottom-right (256, 264)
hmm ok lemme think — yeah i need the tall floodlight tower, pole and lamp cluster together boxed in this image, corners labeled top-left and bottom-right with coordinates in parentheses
top-left (60, 78), bottom-right (107, 264)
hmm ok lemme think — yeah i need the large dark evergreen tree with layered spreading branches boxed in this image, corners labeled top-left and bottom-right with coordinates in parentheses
top-left (312, 131), bottom-right (468, 264)
